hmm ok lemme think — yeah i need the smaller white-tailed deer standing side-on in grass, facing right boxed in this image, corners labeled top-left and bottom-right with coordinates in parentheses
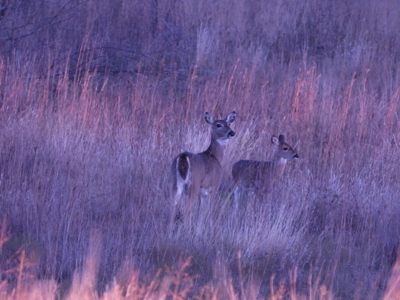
top-left (232, 135), bottom-right (299, 208)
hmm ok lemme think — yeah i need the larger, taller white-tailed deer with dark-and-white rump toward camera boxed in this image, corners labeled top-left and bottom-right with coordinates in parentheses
top-left (171, 112), bottom-right (236, 231)
